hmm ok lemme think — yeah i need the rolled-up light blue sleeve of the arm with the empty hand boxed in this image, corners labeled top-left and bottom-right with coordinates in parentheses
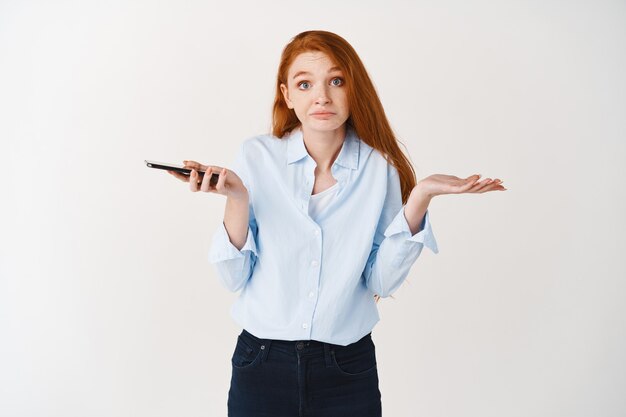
top-left (364, 165), bottom-right (439, 298)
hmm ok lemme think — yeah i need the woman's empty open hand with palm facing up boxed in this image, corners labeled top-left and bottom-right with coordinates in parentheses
top-left (415, 174), bottom-right (506, 198)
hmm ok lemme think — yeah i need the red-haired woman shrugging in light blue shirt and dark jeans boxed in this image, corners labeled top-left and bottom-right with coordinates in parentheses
top-left (169, 31), bottom-right (505, 417)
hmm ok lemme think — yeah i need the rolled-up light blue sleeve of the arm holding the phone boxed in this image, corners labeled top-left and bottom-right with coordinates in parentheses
top-left (209, 142), bottom-right (258, 292)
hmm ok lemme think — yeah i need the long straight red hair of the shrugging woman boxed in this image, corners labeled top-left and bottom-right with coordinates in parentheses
top-left (272, 30), bottom-right (416, 204)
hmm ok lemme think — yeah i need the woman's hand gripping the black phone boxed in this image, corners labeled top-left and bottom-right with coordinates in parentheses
top-left (167, 161), bottom-right (248, 200)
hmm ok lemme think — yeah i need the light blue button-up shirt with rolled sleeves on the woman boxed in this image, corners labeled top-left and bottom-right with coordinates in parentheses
top-left (209, 127), bottom-right (439, 346)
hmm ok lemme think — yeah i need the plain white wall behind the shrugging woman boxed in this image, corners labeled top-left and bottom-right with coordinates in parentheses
top-left (0, 0), bottom-right (626, 417)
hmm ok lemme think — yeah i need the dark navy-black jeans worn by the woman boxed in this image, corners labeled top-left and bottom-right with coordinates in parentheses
top-left (228, 329), bottom-right (382, 417)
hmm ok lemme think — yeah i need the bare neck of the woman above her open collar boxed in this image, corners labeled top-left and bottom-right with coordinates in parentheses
top-left (302, 123), bottom-right (346, 174)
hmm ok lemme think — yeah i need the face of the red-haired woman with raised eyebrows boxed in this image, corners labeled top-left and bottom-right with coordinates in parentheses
top-left (280, 51), bottom-right (350, 131)
